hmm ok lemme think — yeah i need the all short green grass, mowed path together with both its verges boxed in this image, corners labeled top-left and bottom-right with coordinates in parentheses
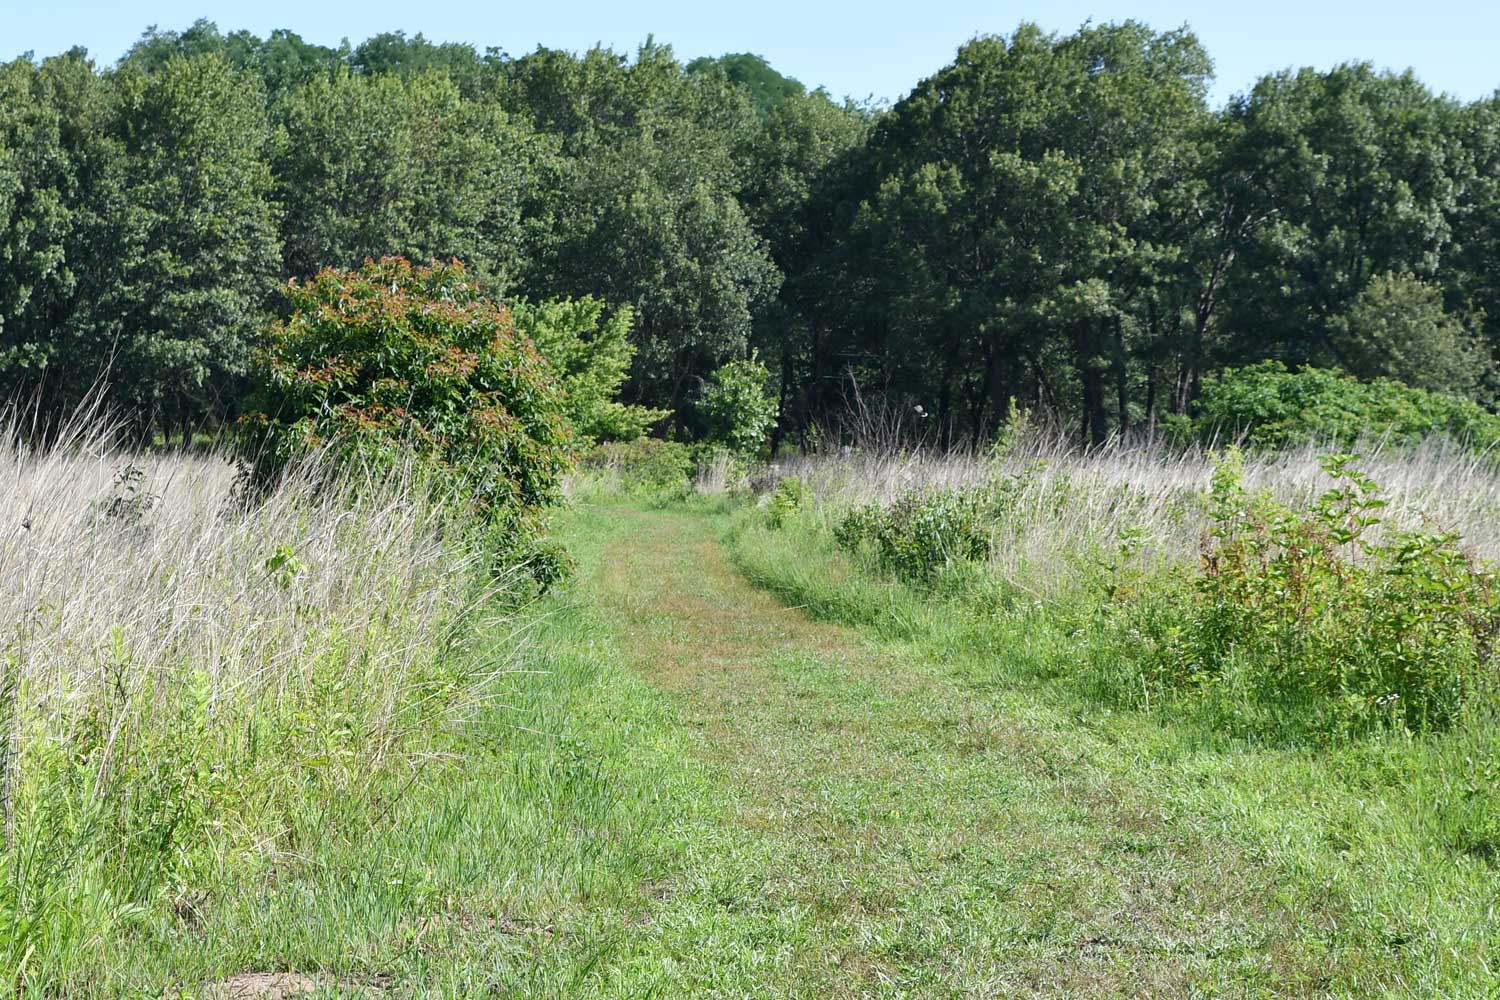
top-left (46, 505), bottom-right (1500, 997)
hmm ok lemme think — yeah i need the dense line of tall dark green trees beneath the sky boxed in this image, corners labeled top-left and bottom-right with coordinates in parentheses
top-left (0, 21), bottom-right (1500, 441)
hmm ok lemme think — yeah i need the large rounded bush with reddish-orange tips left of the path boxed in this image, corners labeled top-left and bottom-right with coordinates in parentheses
top-left (242, 258), bottom-right (573, 579)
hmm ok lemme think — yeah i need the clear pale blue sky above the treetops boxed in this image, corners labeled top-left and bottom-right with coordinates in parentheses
top-left (0, 0), bottom-right (1500, 100)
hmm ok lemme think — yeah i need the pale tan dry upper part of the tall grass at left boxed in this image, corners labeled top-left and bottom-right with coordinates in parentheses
top-left (0, 419), bottom-right (492, 773)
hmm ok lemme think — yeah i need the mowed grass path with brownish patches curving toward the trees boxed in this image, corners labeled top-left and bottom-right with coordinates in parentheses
top-left (567, 508), bottom-right (1338, 997)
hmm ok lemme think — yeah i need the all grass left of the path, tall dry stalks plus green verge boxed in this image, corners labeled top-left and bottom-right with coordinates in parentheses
top-left (0, 422), bottom-right (720, 997)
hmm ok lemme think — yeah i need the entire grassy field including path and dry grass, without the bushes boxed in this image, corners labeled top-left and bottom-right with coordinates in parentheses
top-left (0, 425), bottom-right (1500, 997)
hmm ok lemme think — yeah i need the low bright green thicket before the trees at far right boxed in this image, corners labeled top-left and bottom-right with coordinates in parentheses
top-left (1178, 361), bottom-right (1500, 448)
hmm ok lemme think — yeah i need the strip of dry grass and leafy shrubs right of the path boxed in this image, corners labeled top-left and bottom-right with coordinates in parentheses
top-left (765, 432), bottom-right (1500, 741)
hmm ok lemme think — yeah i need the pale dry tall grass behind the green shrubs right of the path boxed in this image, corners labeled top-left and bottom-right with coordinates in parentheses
top-left (776, 430), bottom-right (1500, 595)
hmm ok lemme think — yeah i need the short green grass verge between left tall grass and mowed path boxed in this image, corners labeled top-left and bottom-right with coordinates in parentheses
top-left (80, 554), bottom-right (698, 997)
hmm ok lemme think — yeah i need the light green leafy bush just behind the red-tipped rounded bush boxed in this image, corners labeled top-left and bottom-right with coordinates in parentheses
top-left (513, 297), bottom-right (669, 441)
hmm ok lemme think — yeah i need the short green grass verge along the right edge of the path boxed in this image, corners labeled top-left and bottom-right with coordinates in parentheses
top-left (729, 503), bottom-right (1500, 997)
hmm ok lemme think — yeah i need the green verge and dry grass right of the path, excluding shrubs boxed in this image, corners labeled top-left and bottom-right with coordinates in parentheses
top-left (729, 445), bottom-right (1500, 997)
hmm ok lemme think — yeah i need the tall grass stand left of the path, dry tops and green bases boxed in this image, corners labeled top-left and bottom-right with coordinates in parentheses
top-left (0, 413), bottom-right (504, 985)
